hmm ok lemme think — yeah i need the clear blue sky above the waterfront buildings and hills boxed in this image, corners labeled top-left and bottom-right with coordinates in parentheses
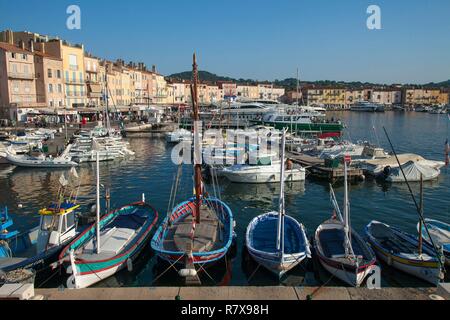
top-left (0, 0), bottom-right (450, 83)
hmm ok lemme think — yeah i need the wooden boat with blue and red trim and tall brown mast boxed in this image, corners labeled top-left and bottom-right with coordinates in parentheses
top-left (151, 54), bottom-right (234, 278)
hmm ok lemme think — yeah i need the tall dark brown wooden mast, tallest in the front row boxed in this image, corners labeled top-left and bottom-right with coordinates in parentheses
top-left (191, 53), bottom-right (202, 223)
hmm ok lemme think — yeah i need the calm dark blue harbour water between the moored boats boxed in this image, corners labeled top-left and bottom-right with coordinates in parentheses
top-left (0, 112), bottom-right (450, 287)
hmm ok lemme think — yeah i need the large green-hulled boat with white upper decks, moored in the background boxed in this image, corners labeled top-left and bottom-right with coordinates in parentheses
top-left (253, 110), bottom-right (344, 135)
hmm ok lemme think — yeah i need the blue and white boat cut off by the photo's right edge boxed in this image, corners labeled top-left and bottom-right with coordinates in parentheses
top-left (417, 219), bottom-right (450, 265)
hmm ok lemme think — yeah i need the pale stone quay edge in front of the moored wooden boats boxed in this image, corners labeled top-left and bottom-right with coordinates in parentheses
top-left (35, 287), bottom-right (450, 301)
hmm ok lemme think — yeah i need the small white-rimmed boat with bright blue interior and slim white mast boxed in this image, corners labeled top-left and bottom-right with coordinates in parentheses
top-left (245, 132), bottom-right (311, 277)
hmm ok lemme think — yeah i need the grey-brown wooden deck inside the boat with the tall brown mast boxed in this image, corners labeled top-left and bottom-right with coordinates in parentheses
top-left (163, 206), bottom-right (221, 252)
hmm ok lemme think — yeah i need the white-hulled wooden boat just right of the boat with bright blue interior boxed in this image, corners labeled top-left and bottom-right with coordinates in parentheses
top-left (314, 156), bottom-right (376, 287)
